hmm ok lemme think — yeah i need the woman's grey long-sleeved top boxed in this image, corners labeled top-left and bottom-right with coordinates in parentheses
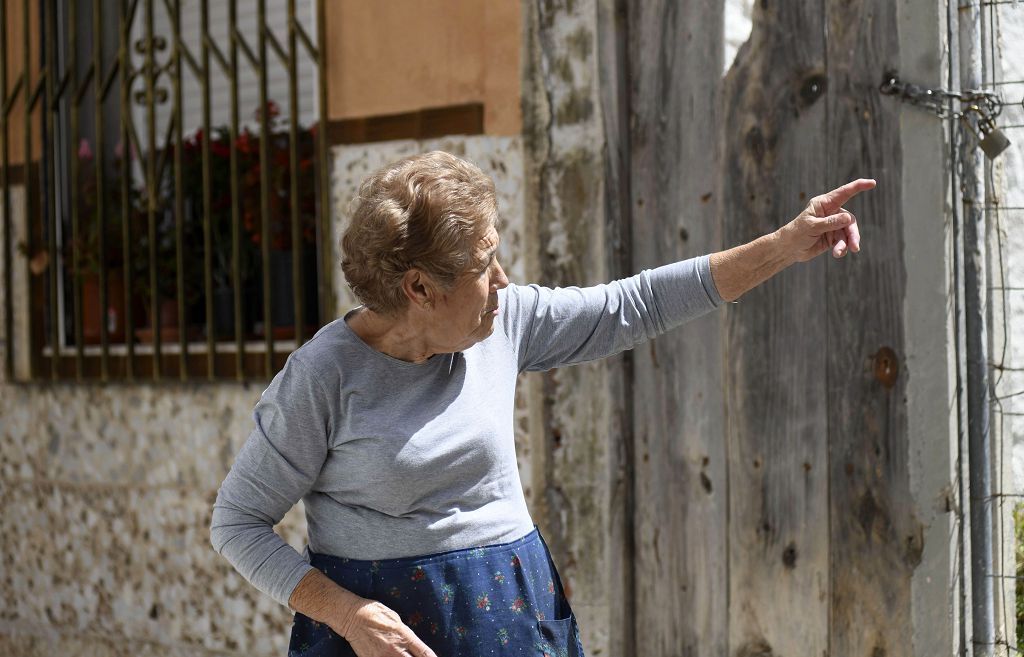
top-left (210, 256), bottom-right (722, 605)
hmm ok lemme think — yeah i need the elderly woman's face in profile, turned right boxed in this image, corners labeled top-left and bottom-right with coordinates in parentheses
top-left (431, 227), bottom-right (509, 352)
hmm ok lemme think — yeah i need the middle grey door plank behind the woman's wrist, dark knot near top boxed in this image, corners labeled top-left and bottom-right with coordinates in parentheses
top-left (721, 2), bottom-right (830, 656)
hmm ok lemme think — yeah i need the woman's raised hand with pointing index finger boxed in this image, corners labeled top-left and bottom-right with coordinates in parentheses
top-left (776, 178), bottom-right (876, 262)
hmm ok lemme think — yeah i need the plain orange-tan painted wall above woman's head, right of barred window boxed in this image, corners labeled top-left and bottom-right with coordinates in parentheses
top-left (325, 0), bottom-right (522, 135)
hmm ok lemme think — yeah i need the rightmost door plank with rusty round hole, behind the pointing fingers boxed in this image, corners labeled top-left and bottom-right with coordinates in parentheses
top-left (824, 0), bottom-right (921, 657)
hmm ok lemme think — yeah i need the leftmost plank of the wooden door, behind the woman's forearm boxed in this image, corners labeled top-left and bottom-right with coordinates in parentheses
top-left (628, 0), bottom-right (728, 657)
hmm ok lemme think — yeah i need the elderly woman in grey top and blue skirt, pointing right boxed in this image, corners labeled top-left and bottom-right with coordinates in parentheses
top-left (211, 152), bottom-right (874, 657)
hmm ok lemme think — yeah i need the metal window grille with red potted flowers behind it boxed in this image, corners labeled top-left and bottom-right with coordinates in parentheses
top-left (0, 0), bottom-right (332, 382)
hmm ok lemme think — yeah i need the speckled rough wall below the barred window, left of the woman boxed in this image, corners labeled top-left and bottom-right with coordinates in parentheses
top-left (0, 385), bottom-right (303, 656)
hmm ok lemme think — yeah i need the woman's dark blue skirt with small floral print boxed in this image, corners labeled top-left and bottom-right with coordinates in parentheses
top-left (288, 529), bottom-right (585, 657)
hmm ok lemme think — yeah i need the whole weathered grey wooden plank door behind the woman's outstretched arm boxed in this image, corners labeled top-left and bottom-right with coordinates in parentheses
top-left (624, 0), bottom-right (922, 657)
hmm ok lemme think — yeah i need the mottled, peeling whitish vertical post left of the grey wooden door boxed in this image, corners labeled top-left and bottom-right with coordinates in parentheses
top-left (522, 0), bottom-right (629, 657)
